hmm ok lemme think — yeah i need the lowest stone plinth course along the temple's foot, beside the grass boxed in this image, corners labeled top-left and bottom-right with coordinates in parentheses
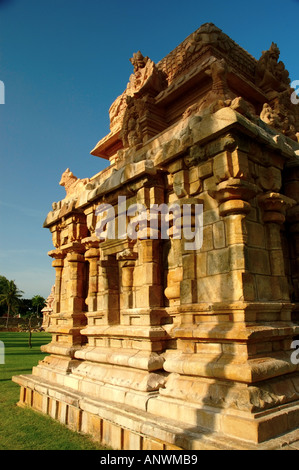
top-left (13, 375), bottom-right (299, 450)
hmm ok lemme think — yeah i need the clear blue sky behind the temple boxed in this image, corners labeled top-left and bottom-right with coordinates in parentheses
top-left (0, 0), bottom-right (299, 298)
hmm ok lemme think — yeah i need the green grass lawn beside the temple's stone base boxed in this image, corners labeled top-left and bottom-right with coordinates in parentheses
top-left (0, 331), bottom-right (109, 450)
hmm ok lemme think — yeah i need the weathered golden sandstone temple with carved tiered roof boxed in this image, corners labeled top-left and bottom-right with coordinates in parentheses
top-left (13, 23), bottom-right (299, 450)
